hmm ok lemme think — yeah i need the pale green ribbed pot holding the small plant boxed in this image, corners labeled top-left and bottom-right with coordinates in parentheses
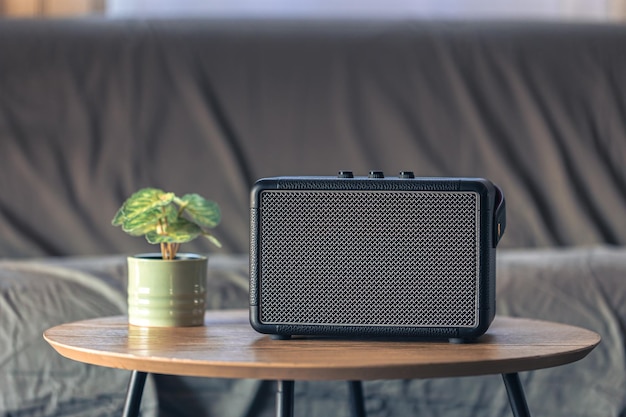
top-left (128, 253), bottom-right (208, 327)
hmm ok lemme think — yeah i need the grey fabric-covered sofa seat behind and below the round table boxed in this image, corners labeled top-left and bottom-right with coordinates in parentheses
top-left (0, 246), bottom-right (626, 417)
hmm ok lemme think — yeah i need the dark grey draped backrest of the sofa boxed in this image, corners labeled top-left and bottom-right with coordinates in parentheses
top-left (0, 19), bottom-right (626, 257)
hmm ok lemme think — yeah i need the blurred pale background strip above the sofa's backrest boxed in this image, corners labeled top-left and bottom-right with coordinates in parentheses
top-left (0, 0), bottom-right (626, 22)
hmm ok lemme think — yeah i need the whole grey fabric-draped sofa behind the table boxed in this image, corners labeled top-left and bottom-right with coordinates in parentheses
top-left (0, 19), bottom-right (626, 417)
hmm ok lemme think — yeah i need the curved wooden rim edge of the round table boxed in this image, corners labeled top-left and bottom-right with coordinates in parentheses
top-left (43, 310), bottom-right (601, 380)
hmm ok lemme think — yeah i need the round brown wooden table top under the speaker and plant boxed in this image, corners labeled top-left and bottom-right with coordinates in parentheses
top-left (44, 310), bottom-right (600, 380)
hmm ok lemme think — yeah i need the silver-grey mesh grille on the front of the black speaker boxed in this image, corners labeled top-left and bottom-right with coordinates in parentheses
top-left (259, 191), bottom-right (479, 327)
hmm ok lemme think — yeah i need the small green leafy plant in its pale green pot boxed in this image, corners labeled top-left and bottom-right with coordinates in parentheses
top-left (112, 188), bottom-right (221, 327)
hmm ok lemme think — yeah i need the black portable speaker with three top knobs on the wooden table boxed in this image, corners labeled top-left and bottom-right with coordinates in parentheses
top-left (250, 171), bottom-right (505, 340)
